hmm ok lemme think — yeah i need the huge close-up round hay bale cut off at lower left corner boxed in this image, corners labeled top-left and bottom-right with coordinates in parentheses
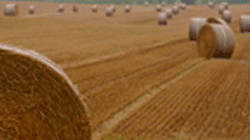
top-left (0, 44), bottom-right (91, 140)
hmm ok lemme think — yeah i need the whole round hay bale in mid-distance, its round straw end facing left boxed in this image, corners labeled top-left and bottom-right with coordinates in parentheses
top-left (197, 24), bottom-right (234, 59)
